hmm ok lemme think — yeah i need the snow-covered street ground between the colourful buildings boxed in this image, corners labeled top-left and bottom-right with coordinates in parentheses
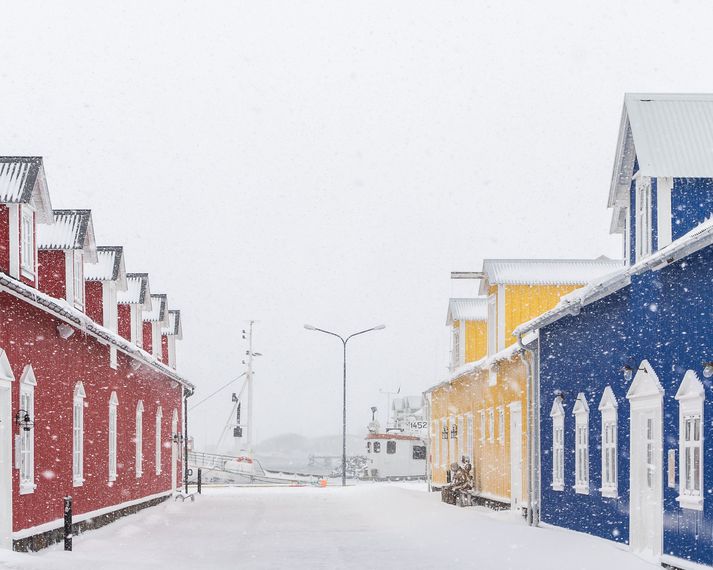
top-left (0, 483), bottom-right (656, 570)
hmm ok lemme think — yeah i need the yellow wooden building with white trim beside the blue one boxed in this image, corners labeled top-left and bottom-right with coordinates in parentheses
top-left (425, 258), bottom-right (620, 508)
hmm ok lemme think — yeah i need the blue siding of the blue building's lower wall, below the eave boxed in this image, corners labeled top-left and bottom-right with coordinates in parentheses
top-left (540, 242), bottom-right (713, 564)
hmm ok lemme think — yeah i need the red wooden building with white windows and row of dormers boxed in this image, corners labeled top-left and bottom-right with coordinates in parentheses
top-left (0, 157), bottom-right (193, 550)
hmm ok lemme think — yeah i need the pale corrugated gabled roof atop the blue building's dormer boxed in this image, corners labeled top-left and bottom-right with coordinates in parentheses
top-left (609, 93), bottom-right (713, 233)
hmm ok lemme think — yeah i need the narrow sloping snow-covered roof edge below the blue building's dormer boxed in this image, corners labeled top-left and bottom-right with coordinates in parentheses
top-left (513, 216), bottom-right (713, 336)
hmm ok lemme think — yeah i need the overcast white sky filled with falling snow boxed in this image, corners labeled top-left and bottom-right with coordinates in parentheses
top-left (0, 0), bottom-right (713, 446)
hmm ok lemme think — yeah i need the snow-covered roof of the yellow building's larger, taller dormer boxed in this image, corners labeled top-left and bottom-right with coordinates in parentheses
top-left (480, 256), bottom-right (623, 295)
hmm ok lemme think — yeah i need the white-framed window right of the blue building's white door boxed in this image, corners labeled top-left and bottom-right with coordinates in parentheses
top-left (676, 370), bottom-right (706, 511)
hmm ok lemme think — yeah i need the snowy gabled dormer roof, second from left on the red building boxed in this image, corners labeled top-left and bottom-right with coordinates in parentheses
top-left (37, 210), bottom-right (97, 263)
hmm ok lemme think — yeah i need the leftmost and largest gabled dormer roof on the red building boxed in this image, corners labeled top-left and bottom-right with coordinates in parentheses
top-left (0, 156), bottom-right (52, 224)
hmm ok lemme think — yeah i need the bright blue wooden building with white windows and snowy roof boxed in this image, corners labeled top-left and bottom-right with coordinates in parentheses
top-left (516, 94), bottom-right (713, 569)
